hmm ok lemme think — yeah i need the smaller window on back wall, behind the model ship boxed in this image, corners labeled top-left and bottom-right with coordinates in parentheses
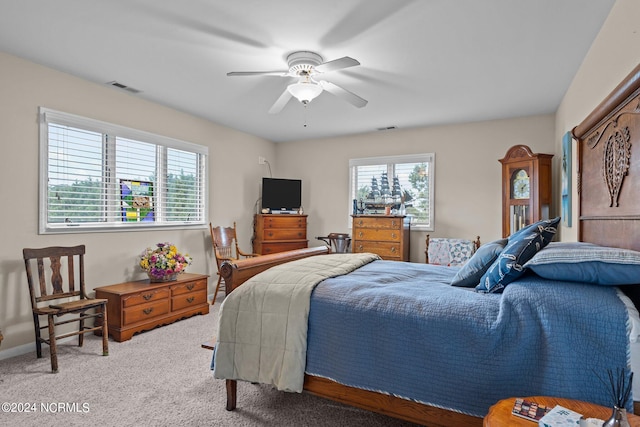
top-left (349, 153), bottom-right (435, 230)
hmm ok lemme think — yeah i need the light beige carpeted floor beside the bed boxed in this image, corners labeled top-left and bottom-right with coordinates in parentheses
top-left (0, 302), bottom-right (420, 427)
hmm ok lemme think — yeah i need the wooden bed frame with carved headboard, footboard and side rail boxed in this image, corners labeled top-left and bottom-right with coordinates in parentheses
top-left (221, 65), bottom-right (640, 427)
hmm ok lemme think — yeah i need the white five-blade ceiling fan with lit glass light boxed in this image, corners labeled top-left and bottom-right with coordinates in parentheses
top-left (227, 51), bottom-right (367, 114)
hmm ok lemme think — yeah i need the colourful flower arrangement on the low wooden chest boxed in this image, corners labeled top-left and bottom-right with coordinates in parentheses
top-left (139, 242), bottom-right (192, 280)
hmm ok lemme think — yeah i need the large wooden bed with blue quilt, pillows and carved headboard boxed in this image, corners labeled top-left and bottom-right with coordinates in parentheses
top-left (212, 67), bottom-right (640, 426)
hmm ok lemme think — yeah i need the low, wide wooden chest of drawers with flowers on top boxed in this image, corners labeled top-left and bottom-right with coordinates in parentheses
top-left (94, 273), bottom-right (209, 342)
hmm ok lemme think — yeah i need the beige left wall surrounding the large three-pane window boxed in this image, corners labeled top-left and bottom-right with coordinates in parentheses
top-left (0, 53), bottom-right (275, 357)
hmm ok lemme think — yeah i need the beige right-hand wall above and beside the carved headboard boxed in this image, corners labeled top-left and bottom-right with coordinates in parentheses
top-left (555, 0), bottom-right (640, 241)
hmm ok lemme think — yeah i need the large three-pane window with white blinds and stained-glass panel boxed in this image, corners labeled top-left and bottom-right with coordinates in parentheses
top-left (39, 108), bottom-right (208, 233)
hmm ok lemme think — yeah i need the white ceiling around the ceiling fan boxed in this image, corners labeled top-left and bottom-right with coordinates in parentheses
top-left (0, 0), bottom-right (615, 142)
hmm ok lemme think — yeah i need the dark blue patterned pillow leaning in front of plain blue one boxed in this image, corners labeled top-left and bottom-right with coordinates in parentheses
top-left (476, 217), bottom-right (560, 293)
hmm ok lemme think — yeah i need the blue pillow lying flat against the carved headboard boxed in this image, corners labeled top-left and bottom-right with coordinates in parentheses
top-left (524, 242), bottom-right (640, 286)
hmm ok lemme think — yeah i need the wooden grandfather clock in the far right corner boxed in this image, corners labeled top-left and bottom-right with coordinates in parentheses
top-left (500, 145), bottom-right (553, 237)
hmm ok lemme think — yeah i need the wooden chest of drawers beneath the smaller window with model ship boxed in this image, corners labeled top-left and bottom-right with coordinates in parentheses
top-left (351, 215), bottom-right (411, 261)
